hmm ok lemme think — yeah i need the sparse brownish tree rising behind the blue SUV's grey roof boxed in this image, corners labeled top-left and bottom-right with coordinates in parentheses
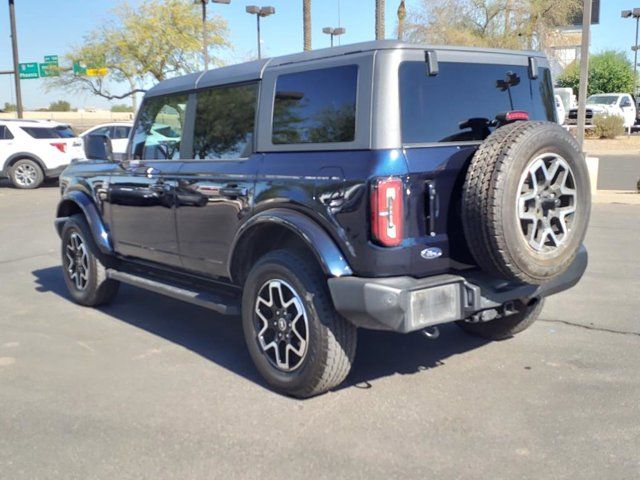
top-left (405, 0), bottom-right (582, 50)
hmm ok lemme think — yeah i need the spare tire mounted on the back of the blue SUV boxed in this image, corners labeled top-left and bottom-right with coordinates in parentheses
top-left (462, 122), bottom-right (591, 285)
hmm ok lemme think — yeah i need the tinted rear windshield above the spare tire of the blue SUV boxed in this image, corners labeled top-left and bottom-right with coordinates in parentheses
top-left (400, 62), bottom-right (555, 143)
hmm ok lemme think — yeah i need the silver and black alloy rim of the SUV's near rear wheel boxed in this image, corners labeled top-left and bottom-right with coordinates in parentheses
top-left (254, 280), bottom-right (309, 372)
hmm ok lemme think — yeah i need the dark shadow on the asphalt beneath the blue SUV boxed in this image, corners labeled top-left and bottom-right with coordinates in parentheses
top-left (32, 267), bottom-right (486, 390)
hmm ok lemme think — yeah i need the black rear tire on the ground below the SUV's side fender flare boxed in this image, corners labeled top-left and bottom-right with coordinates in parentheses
top-left (242, 250), bottom-right (357, 398)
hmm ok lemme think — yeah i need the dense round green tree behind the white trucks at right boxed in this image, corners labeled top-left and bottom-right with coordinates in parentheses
top-left (557, 50), bottom-right (633, 95)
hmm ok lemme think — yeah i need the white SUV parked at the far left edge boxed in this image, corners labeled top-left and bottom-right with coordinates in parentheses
top-left (0, 119), bottom-right (84, 188)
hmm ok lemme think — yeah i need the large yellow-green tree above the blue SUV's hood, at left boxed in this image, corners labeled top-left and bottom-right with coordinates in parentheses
top-left (47, 0), bottom-right (228, 108)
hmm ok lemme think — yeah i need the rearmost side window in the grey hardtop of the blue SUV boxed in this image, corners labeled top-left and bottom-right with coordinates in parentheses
top-left (273, 65), bottom-right (358, 144)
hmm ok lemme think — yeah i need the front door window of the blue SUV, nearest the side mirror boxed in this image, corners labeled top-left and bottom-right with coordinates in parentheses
top-left (132, 95), bottom-right (187, 160)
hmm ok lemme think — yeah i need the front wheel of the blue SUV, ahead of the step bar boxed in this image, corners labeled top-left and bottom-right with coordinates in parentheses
top-left (61, 215), bottom-right (120, 307)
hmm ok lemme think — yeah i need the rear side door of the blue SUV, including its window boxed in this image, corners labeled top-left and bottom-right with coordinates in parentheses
top-left (176, 82), bottom-right (260, 277)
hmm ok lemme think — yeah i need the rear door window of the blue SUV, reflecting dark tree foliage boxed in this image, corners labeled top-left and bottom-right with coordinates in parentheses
top-left (193, 83), bottom-right (258, 160)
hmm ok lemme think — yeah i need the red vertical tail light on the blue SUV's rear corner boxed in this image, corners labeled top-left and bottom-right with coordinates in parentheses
top-left (371, 177), bottom-right (404, 247)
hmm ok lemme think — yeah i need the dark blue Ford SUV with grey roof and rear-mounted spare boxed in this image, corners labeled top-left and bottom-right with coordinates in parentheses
top-left (56, 41), bottom-right (590, 397)
